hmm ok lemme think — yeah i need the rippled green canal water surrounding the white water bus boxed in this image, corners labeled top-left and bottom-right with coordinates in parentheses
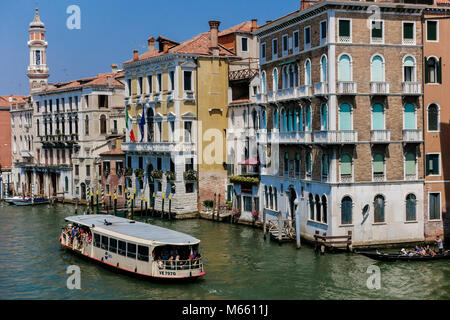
top-left (0, 203), bottom-right (450, 300)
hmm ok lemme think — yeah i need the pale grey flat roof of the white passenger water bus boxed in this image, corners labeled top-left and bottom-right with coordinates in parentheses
top-left (65, 214), bottom-right (200, 245)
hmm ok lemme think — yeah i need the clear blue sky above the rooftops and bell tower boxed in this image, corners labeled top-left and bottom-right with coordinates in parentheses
top-left (0, 0), bottom-right (300, 95)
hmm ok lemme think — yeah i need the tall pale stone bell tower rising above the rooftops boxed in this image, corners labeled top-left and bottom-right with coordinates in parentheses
top-left (27, 8), bottom-right (50, 94)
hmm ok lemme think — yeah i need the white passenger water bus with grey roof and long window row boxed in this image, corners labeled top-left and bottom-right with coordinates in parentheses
top-left (59, 214), bottom-right (205, 279)
